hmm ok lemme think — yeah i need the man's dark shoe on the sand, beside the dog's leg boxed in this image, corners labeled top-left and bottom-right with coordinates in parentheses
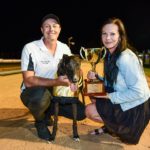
top-left (35, 121), bottom-right (51, 140)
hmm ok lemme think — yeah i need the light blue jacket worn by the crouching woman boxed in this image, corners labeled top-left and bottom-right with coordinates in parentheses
top-left (108, 49), bottom-right (150, 111)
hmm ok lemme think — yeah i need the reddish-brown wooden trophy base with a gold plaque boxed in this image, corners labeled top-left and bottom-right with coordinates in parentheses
top-left (84, 79), bottom-right (106, 96)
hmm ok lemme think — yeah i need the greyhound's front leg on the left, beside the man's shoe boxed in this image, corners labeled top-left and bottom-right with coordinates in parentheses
top-left (51, 102), bottom-right (59, 141)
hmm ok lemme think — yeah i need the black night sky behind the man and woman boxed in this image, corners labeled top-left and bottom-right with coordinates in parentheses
top-left (0, 0), bottom-right (150, 58)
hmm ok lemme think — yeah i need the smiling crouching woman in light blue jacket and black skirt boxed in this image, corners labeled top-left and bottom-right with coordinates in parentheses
top-left (85, 18), bottom-right (150, 144)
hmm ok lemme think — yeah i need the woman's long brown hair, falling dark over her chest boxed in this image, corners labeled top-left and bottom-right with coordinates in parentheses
top-left (101, 18), bottom-right (128, 87)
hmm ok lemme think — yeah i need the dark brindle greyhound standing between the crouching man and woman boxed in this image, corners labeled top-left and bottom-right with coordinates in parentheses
top-left (50, 54), bottom-right (85, 141)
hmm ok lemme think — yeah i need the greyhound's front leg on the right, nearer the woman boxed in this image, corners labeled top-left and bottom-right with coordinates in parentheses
top-left (72, 103), bottom-right (80, 141)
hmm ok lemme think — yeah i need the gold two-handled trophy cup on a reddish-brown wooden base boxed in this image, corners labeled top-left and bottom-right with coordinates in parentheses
top-left (80, 47), bottom-right (106, 96)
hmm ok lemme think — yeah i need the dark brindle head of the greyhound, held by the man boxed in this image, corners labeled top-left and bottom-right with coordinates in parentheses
top-left (57, 54), bottom-right (81, 83)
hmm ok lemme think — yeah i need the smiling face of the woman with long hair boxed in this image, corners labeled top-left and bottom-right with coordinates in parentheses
top-left (101, 24), bottom-right (120, 53)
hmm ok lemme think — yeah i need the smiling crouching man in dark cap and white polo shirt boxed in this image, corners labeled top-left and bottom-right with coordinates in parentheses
top-left (20, 14), bottom-right (71, 140)
